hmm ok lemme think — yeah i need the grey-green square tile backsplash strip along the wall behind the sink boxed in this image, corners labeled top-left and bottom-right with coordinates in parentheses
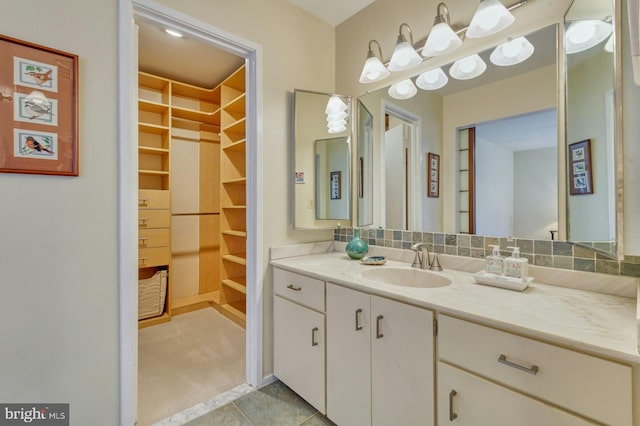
top-left (333, 228), bottom-right (640, 277)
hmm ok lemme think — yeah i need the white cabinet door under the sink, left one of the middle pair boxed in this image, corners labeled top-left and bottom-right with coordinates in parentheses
top-left (326, 283), bottom-right (371, 426)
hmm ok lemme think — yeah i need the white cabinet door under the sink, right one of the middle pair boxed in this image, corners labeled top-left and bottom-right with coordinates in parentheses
top-left (371, 296), bottom-right (435, 426)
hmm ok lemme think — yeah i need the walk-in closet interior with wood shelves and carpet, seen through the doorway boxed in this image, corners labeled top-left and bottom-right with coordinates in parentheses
top-left (137, 22), bottom-right (247, 425)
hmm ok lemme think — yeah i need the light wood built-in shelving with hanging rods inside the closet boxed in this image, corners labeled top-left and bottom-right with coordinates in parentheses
top-left (138, 67), bottom-right (247, 327)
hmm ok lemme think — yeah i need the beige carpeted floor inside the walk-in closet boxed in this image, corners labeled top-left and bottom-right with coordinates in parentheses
top-left (137, 308), bottom-right (246, 426)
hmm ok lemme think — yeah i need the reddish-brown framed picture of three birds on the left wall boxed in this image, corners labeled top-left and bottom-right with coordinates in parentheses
top-left (0, 35), bottom-right (78, 176)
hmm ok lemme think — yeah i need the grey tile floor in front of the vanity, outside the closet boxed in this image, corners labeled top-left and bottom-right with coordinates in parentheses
top-left (185, 381), bottom-right (335, 426)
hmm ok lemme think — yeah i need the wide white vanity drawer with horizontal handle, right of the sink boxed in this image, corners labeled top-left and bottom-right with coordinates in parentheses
top-left (438, 315), bottom-right (632, 425)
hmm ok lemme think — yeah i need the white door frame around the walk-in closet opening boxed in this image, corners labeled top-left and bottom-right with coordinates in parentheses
top-left (118, 0), bottom-right (265, 425)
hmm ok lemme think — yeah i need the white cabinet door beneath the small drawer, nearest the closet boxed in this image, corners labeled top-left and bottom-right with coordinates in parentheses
top-left (273, 296), bottom-right (326, 414)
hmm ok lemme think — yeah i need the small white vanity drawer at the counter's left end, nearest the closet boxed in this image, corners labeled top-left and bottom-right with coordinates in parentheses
top-left (273, 268), bottom-right (324, 312)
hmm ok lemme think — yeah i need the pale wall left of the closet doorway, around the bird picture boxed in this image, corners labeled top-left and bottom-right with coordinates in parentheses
top-left (0, 0), bottom-right (119, 425)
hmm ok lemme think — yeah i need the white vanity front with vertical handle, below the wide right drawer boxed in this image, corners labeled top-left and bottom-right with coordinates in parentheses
top-left (438, 362), bottom-right (596, 426)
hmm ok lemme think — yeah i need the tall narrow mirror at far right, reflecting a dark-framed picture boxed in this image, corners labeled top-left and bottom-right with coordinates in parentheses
top-left (564, 0), bottom-right (622, 257)
